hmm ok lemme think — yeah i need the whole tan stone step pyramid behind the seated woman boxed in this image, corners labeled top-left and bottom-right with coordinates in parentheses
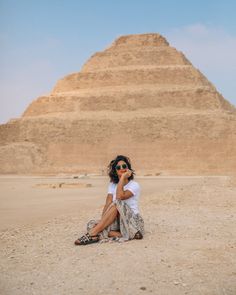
top-left (0, 34), bottom-right (236, 175)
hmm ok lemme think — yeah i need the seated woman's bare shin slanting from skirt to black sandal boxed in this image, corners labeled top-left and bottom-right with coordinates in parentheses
top-left (89, 205), bottom-right (118, 236)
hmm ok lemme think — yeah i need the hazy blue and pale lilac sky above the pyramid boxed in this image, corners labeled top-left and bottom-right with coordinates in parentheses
top-left (0, 0), bottom-right (236, 123)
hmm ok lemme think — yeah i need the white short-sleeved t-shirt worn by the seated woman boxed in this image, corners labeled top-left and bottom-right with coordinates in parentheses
top-left (107, 180), bottom-right (140, 214)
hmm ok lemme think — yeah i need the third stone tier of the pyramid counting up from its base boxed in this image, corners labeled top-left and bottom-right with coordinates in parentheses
top-left (53, 65), bottom-right (212, 93)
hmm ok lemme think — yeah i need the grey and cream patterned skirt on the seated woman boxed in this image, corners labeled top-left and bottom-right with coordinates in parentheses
top-left (87, 200), bottom-right (144, 242)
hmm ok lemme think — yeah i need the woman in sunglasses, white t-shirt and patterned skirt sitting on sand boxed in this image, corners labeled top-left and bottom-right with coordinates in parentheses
top-left (75, 155), bottom-right (144, 245)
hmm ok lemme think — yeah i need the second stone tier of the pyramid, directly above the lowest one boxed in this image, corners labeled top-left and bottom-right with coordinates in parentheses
top-left (24, 85), bottom-right (232, 117)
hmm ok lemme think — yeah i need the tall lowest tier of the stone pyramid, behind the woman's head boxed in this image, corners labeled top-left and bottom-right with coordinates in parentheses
top-left (0, 110), bottom-right (236, 175)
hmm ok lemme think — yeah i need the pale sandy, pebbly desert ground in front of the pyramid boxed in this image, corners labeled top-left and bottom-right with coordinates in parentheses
top-left (0, 176), bottom-right (236, 295)
